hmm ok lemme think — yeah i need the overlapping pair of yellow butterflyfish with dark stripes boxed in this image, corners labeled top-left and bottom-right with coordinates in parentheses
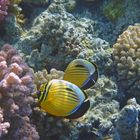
top-left (36, 59), bottom-right (98, 119)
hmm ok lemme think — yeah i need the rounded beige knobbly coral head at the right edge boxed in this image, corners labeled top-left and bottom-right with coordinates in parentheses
top-left (113, 24), bottom-right (140, 100)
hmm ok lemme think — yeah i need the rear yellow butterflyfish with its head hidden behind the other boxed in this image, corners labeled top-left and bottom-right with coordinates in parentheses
top-left (63, 59), bottom-right (98, 90)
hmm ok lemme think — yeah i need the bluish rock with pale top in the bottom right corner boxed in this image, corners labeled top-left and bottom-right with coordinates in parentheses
top-left (114, 99), bottom-right (140, 140)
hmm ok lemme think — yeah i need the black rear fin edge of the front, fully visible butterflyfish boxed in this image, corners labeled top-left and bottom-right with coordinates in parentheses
top-left (65, 100), bottom-right (90, 119)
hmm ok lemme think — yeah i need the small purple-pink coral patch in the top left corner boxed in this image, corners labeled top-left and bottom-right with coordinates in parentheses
top-left (0, 0), bottom-right (10, 20)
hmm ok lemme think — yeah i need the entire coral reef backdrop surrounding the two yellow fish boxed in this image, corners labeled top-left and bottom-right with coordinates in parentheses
top-left (0, 0), bottom-right (140, 140)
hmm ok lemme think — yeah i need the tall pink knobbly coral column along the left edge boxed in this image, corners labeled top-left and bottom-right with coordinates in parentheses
top-left (0, 44), bottom-right (39, 140)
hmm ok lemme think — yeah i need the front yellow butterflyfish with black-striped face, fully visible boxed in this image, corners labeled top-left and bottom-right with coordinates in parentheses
top-left (36, 79), bottom-right (90, 119)
